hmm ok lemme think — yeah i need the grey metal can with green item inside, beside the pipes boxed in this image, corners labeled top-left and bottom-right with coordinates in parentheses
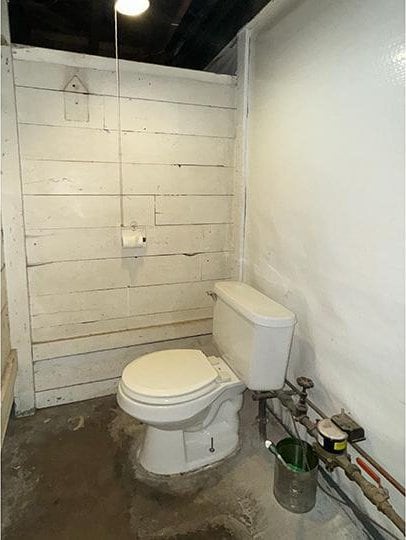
top-left (273, 438), bottom-right (319, 514)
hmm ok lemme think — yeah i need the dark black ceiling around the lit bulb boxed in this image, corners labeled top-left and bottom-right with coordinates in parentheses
top-left (9, 0), bottom-right (269, 69)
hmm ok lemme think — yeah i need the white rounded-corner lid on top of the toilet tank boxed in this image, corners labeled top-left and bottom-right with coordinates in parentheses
top-left (214, 281), bottom-right (296, 327)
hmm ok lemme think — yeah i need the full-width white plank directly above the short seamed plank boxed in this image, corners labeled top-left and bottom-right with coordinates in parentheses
top-left (23, 160), bottom-right (233, 195)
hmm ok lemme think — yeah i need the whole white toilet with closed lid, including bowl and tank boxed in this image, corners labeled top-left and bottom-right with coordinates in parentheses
top-left (117, 281), bottom-right (295, 474)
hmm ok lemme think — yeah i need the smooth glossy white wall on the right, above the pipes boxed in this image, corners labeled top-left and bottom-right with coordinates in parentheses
top-left (244, 0), bottom-right (405, 528)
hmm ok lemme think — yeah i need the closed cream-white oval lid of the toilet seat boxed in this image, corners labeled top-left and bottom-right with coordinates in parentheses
top-left (121, 349), bottom-right (218, 400)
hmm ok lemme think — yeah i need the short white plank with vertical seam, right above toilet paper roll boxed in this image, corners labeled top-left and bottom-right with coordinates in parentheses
top-left (156, 196), bottom-right (233, 225)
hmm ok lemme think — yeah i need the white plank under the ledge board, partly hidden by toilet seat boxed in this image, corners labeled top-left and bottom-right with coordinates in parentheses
top-left (34, 335), bottom-right (215, 392)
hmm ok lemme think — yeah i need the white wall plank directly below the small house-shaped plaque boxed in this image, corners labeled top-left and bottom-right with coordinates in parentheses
top-left (20, 124), bottom-right (233, 166)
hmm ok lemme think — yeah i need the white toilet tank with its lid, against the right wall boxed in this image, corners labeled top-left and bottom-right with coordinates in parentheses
top-left (213, 281), bottom-right (296, 390)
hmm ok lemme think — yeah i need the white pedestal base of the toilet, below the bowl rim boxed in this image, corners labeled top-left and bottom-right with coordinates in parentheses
top-left (138, 394), bottom-right (243, 475)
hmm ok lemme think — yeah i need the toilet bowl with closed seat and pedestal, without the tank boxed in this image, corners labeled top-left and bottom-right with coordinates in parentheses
top-left (117, 349), bottom-right (246, 474)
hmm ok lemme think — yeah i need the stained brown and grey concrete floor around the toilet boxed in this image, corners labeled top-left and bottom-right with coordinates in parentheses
top-left (2, 394), bottom-right (367, 540)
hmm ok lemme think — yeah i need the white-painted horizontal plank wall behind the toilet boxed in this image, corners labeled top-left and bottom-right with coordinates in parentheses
top-left (14, 48), bottom-right (235, 407)
